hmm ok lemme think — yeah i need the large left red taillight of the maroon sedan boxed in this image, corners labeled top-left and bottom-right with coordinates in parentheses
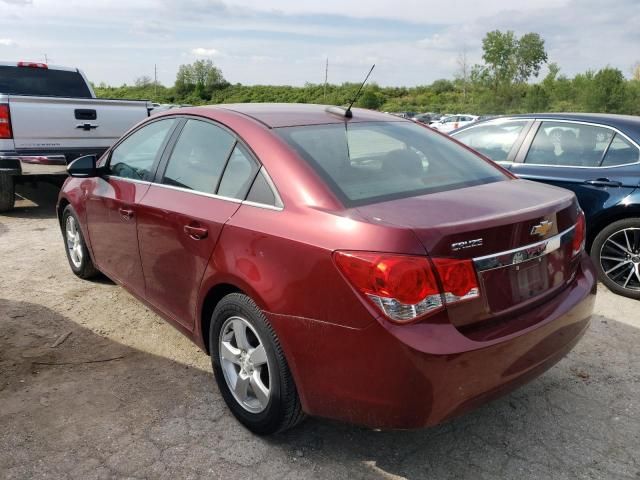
top-left (334, 252), bottom-right (479, 323)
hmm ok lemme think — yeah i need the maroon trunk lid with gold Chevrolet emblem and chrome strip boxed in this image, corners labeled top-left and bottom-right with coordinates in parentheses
top-left (358, 180), bottom-right (578, 327)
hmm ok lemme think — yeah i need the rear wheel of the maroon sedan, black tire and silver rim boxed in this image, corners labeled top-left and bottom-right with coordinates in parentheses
top-left (209, 293), bottom-right (305, 435)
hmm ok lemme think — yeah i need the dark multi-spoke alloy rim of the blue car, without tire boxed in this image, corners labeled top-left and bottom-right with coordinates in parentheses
top-left (600, 228), bottom-right (640, 291)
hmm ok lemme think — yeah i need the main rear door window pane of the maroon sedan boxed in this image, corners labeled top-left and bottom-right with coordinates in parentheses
top-left (162, 120), bottom-right (235, 194)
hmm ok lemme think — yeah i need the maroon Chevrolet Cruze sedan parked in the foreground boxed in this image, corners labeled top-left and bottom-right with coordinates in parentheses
top-left (58, 104), bottom-right (595, 434)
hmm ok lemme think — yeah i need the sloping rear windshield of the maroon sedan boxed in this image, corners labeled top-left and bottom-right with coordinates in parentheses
top-left (275, 122), bottom-right (508, 206)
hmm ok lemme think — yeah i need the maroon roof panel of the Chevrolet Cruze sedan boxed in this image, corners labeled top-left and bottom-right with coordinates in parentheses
top-left (180, 103), bottom-right (409, 128)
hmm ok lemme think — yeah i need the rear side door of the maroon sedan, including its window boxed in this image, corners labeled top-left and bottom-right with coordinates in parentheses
top-left (138, 118), bottom-right (259, 330)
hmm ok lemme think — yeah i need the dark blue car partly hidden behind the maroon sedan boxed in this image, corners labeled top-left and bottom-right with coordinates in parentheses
top-left (451, 113), bottom-right (640, 299)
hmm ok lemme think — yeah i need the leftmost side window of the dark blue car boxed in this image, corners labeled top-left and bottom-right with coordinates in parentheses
top-left (455, 120), bottom-right (527, 162)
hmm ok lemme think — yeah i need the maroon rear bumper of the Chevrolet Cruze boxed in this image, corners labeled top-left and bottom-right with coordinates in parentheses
top-left (267, 255), bottom-right (596, 428)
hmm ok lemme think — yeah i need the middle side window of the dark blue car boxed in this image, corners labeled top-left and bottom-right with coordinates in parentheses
top-left (525, 121), bottom-right (614, 167)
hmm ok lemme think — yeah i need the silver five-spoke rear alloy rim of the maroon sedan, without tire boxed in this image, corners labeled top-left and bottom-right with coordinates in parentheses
top-left (219, 316), bottom-right (271, 413)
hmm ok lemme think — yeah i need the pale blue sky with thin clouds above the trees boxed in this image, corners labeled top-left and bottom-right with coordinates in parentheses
top-left (0, 0), bottom-right (640, 86)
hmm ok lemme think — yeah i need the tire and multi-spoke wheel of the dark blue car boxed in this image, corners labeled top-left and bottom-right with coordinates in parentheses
top-left (591, 218), bottom-right (640, 300)
